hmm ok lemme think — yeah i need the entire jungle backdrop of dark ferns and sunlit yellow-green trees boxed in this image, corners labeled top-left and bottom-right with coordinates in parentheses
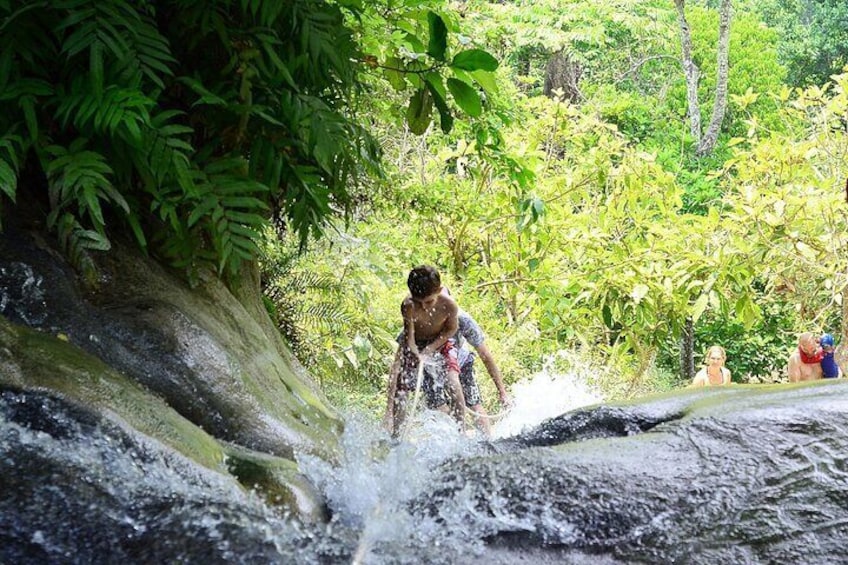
top-left (0, 0), bottom-right (848, 417)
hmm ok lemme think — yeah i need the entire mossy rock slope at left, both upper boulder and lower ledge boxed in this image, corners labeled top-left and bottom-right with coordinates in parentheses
top-left (0, 229), bottom-right (341, 520)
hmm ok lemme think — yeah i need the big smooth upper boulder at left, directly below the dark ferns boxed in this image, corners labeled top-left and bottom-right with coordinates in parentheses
top-left (0, 225), bottom-right (341, 458)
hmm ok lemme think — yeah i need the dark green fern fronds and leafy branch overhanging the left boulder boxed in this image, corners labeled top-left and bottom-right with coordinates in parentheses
top-left (0, 0), bottom-right (504, 275)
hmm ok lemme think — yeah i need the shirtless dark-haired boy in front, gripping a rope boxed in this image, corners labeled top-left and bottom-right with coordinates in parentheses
top-left (387, 265), bottom-right (465, 433)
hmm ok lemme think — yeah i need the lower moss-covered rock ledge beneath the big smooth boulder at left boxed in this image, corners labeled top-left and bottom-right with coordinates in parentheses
top-left (0, 317), bottom-right (327, 521)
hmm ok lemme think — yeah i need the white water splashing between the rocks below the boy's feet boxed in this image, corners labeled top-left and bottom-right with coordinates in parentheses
top-left (298, 411), bottom-right (496, 563)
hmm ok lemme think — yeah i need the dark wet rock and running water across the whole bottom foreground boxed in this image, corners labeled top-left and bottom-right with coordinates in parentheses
top-left (0, 372), bottom-right (848, 564)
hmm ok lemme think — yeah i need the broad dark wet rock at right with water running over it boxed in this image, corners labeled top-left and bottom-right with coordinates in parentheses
top-left (415, 382), bottom-right (848, 563)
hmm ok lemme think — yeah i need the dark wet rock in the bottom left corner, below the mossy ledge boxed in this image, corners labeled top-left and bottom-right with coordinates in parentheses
top-left (0, 389), bottom-right (318, 564)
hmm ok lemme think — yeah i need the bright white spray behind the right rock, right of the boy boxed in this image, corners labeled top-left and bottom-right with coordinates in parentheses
top-left (492, 351), bottom-right (604, 438)
